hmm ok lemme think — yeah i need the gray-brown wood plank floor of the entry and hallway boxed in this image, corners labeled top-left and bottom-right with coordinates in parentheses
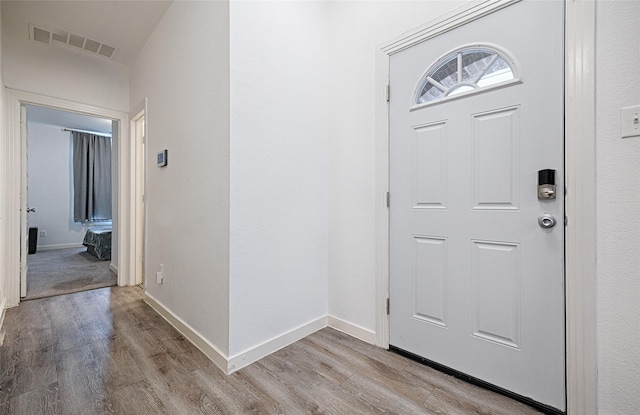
top-left (0, 287), bottom-right (538, 415)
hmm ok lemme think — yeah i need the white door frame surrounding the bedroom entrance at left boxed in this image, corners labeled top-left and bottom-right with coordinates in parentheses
top-left (0, 87), bottom-right (136, 307)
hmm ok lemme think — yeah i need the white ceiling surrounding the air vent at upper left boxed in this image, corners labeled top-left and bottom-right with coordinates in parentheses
top-left (0, 0), bottom-right (171, 64)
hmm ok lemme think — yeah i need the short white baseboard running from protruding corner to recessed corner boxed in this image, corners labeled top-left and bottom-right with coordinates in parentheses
top-left (227, 316), bottom-right (327, 375)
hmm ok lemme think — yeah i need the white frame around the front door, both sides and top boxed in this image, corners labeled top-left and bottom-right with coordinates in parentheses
top-left (375, 0), bottom-right (597, 415)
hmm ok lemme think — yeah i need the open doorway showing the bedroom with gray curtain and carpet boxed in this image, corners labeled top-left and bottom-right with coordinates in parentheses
top-left (20, 105), bottom-right (118, 301)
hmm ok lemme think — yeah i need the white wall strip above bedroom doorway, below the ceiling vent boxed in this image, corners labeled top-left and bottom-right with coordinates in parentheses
top-left (2, 35), bottom-right (129, 112)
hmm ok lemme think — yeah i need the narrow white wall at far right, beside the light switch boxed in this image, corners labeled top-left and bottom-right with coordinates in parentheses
top-left (596, 1), bottom-right (640, 414)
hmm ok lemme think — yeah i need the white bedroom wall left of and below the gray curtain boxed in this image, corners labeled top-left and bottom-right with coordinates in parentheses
top-left (27, 122), bottom-right (86, 248)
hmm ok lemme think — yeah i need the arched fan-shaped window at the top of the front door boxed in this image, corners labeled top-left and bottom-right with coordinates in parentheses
top-left (413, 45), bottom-right (521, 108)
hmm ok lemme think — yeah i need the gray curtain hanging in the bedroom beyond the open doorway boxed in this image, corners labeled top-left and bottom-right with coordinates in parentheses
top-left (71, 131), bottom-right (111, 222)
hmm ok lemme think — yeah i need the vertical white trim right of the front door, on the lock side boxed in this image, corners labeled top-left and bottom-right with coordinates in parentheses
top-left (564, 0), bottom-right (598, 414)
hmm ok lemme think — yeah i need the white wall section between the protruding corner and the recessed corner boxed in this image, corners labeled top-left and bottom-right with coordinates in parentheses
top-left (229, 1), bottom-right (329, 356)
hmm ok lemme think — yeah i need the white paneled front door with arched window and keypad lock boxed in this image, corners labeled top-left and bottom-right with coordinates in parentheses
top-left (389, 1), bottom-right (565, 410)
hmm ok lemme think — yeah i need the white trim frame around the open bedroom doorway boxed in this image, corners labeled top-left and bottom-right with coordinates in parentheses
top-left (0, 88), bottom-right (137, 307)
